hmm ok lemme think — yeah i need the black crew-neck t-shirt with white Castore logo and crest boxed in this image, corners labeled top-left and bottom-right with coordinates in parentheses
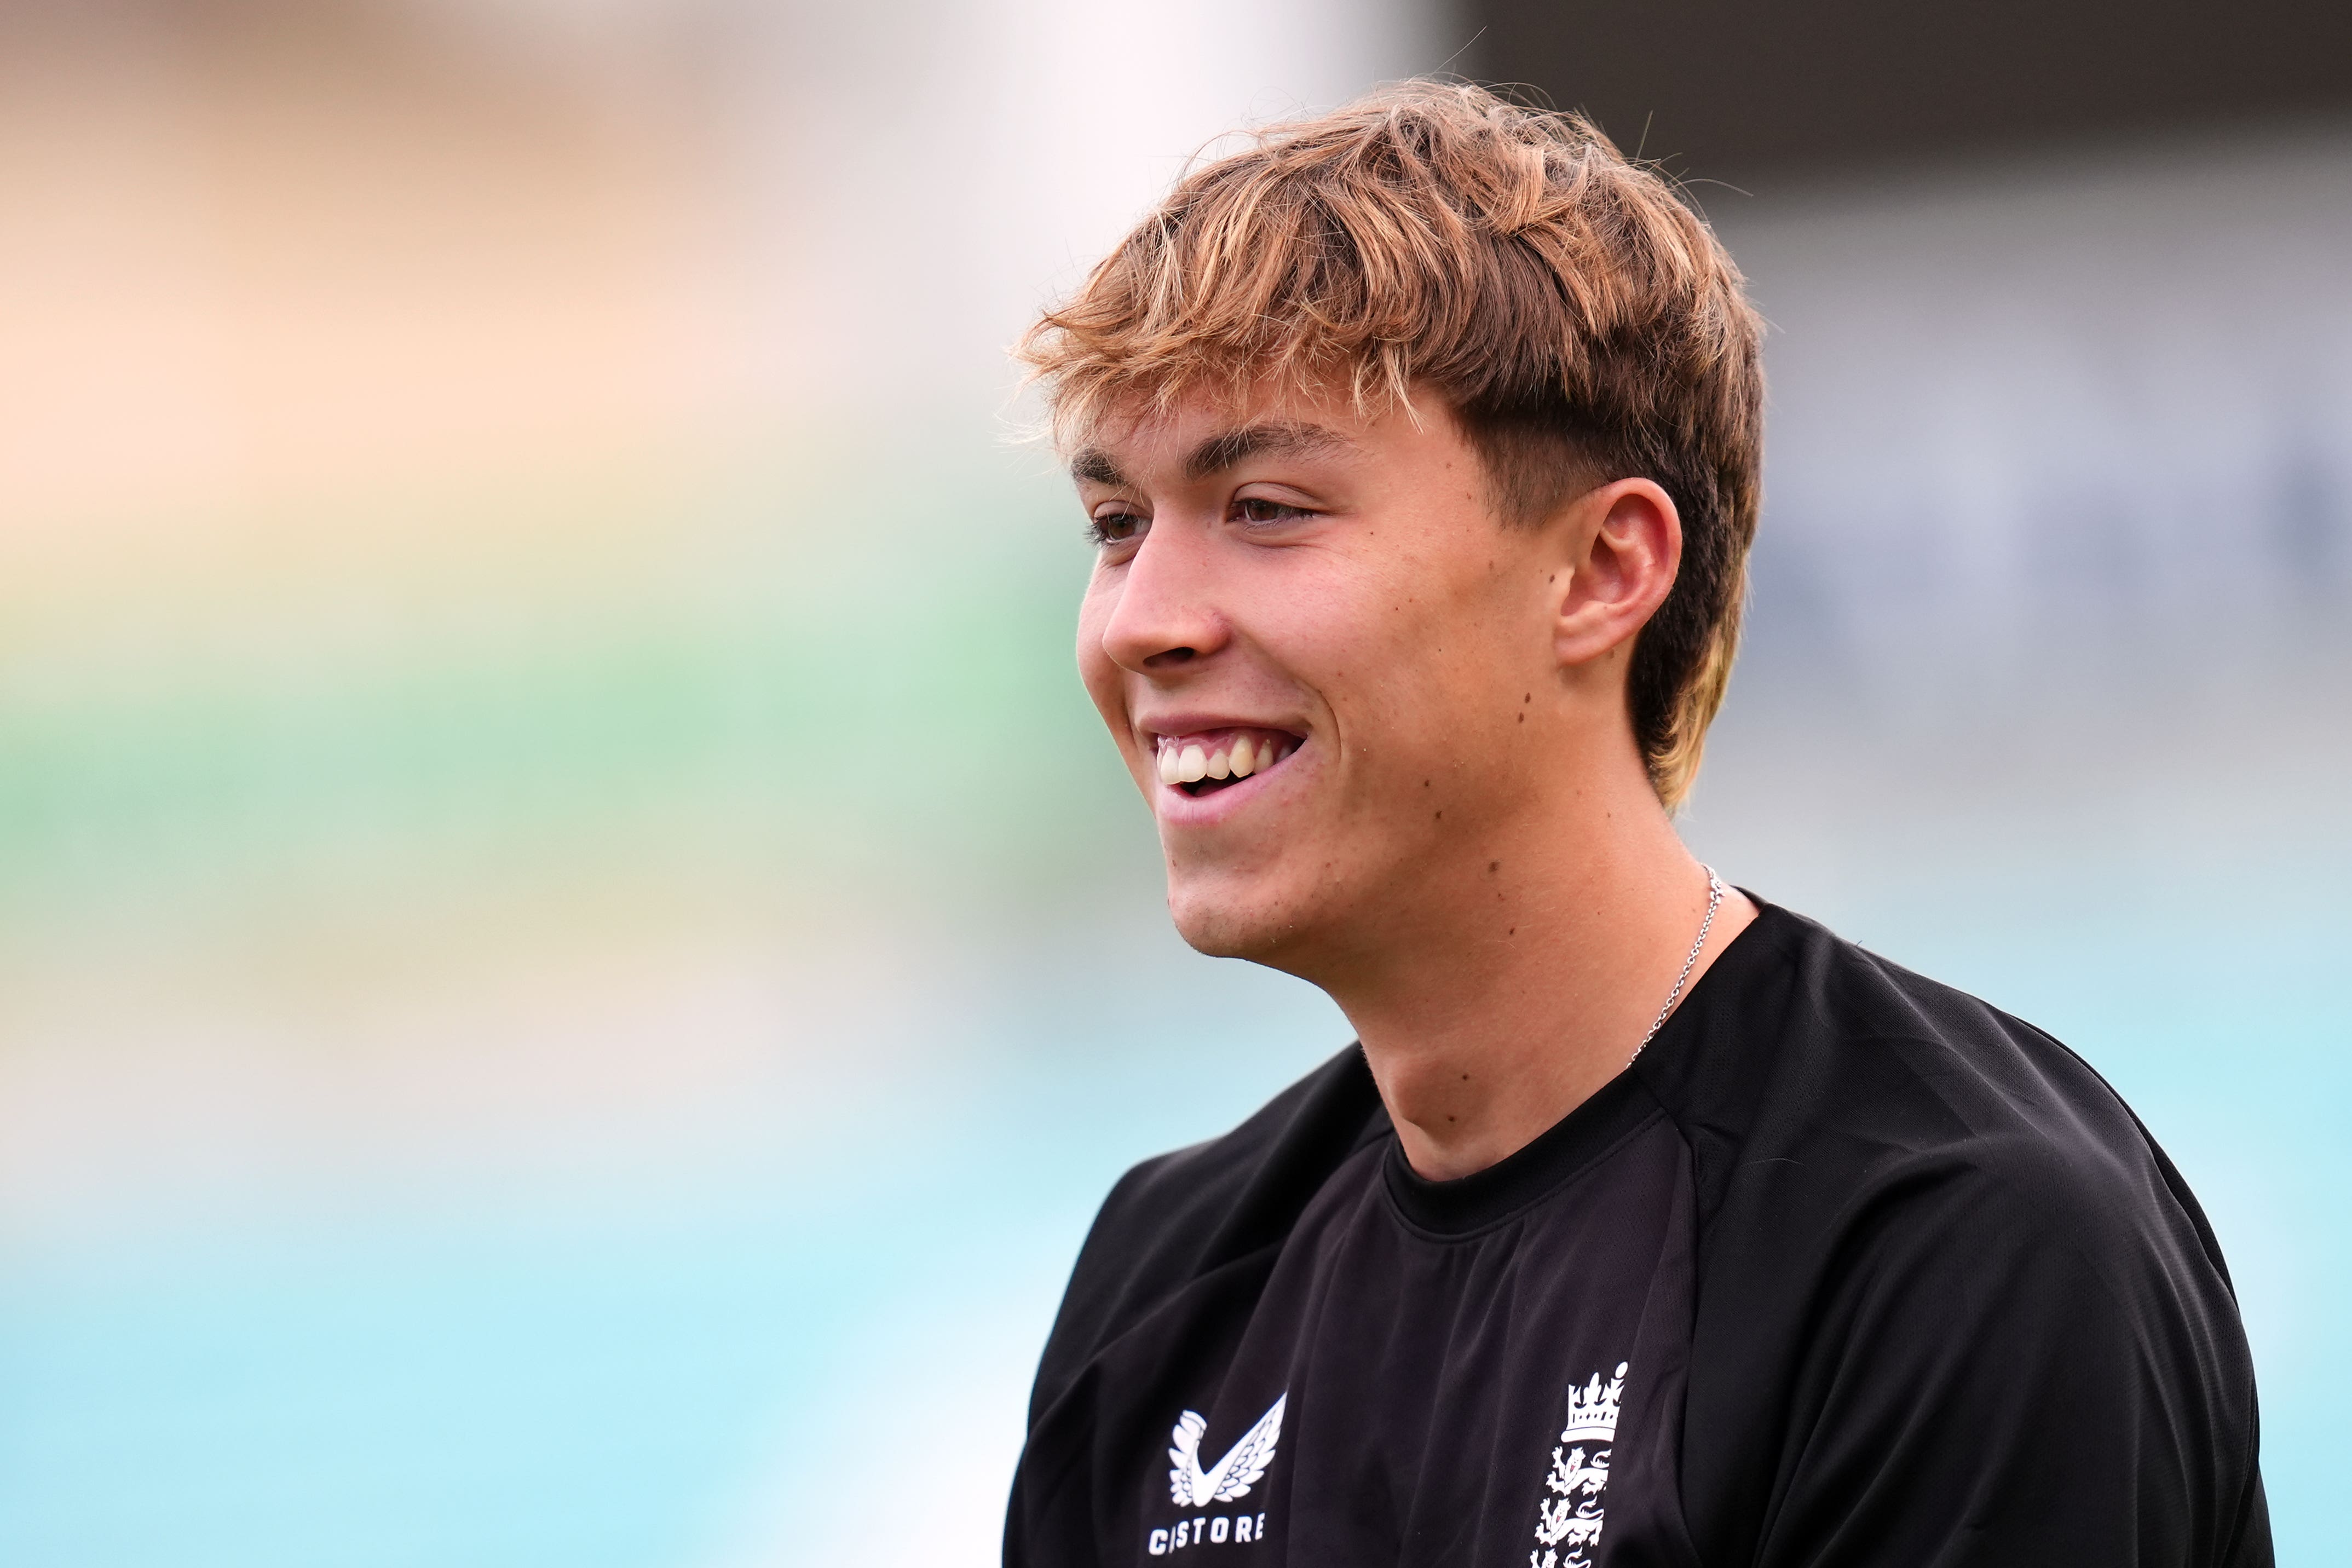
top-left (1004, 905), bottom-right (2272, 1568)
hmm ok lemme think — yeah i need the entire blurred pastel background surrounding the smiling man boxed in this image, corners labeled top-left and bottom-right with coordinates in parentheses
top-left (0, 0), bottom-right (2352, 1568)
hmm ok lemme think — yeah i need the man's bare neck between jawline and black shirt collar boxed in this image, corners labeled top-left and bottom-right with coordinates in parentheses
top-left (1312, 757), bottom-right (1755, 1180)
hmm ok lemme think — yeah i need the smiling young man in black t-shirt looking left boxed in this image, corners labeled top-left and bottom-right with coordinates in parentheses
top-left (1004, 85), bottom-right (2270, 1568)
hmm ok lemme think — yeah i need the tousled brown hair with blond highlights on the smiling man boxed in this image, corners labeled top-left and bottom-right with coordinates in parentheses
top-left (1018, 80), bottom-right (1764, 809)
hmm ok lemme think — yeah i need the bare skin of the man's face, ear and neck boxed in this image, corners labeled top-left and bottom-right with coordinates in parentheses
top-left (1073, 388), bottom-right (1755, 1178)
